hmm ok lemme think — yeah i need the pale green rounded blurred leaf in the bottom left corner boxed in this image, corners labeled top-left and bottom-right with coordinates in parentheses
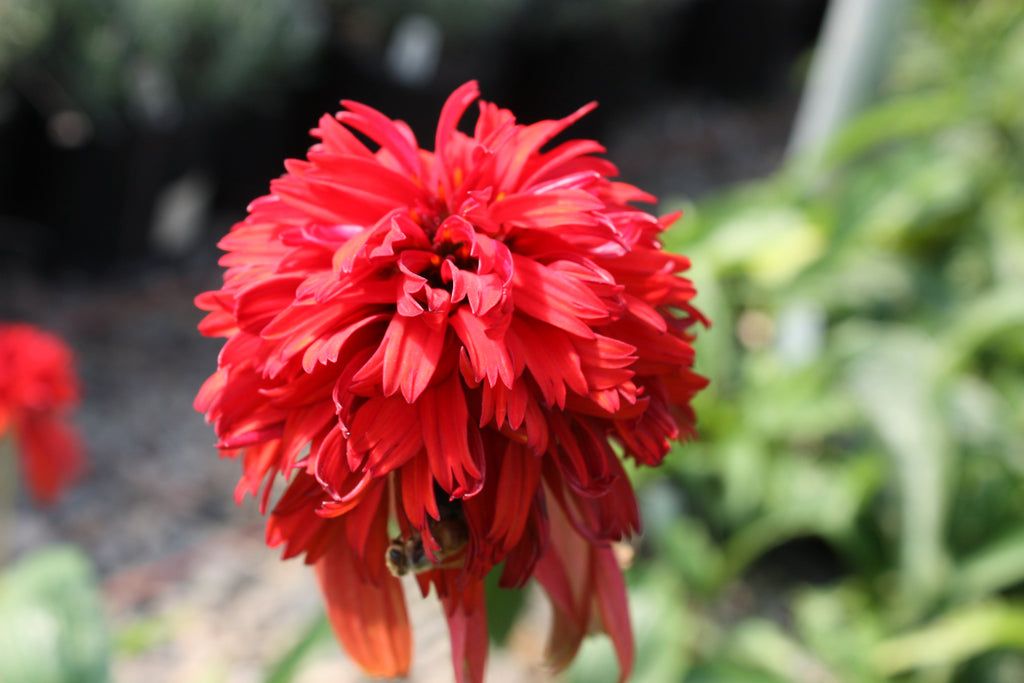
top-left (0, 547), bottom-right (109, 683)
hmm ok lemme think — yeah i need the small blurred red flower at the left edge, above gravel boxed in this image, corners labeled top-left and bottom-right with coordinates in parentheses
top-left (0, 325), bottom-right (85, 504)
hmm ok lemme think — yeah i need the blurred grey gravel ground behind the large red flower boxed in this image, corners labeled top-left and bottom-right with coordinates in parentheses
top-left (0, 90), bottom-right (794, 683)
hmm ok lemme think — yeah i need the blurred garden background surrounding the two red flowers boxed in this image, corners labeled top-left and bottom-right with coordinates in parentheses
top-left (0, 0), bottom-right (1024, 683)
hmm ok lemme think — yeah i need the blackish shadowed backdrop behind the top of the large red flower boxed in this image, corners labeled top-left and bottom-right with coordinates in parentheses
top-left (0, 0), bottom-right (824, 278)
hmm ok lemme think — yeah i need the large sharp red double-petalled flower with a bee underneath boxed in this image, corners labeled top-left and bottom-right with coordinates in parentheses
top-left (196, 83), bottom-right (706, 681)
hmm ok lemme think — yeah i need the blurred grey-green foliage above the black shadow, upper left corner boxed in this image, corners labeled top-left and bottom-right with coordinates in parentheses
top-left (0, 0), bottom-right (328, 120)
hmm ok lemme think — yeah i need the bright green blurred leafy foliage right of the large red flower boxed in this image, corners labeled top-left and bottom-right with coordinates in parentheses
top-left (618, 0), bottom-right (1024, 683)
